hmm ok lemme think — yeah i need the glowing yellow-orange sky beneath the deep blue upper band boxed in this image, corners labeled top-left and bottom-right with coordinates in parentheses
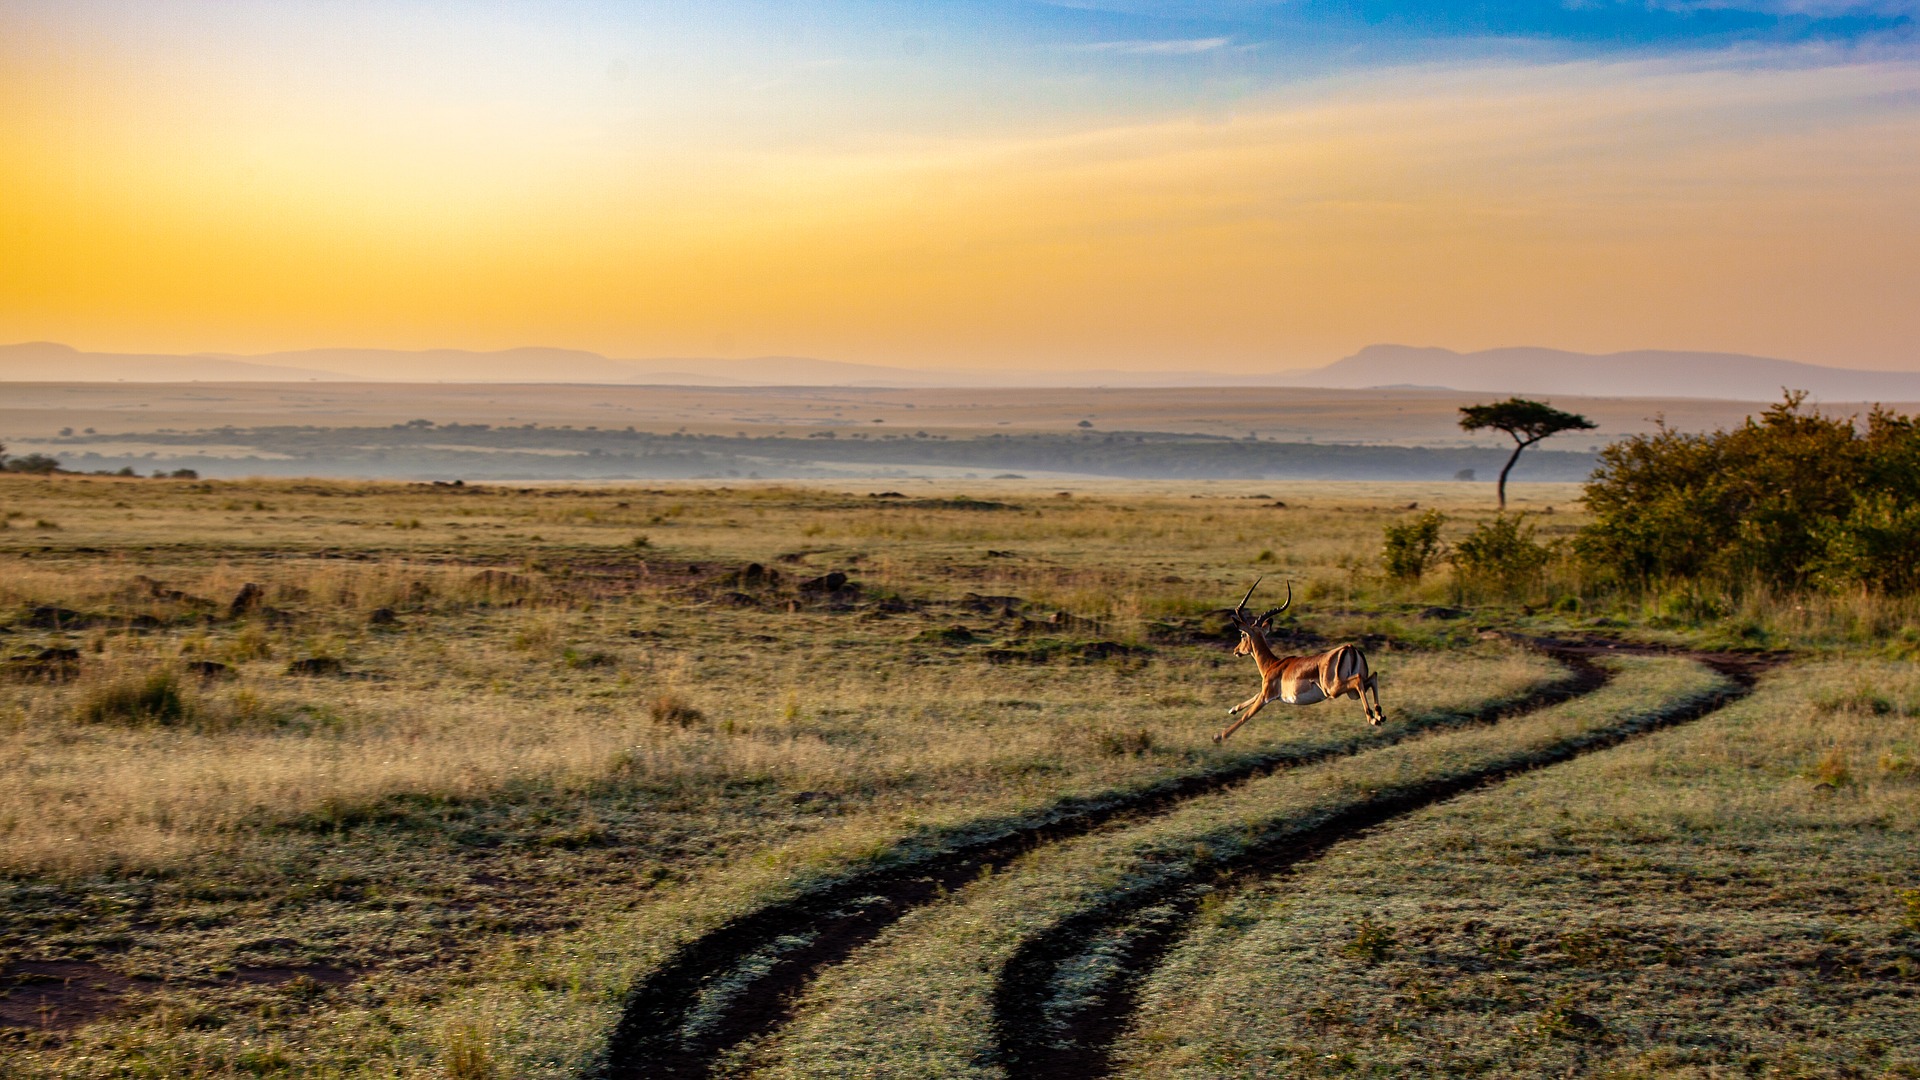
top-left (0, 6), bottom-right (1920, 371)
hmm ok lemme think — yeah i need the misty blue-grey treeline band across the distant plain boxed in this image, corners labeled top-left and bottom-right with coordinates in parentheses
top-left (45, 421), bottom-right (1597, 480)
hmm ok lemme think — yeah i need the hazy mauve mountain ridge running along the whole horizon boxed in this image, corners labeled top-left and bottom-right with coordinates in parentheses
top-left (0, 342), bottom-right (1920, 402)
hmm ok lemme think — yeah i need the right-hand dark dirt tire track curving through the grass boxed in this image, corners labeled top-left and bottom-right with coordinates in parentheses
top-left (993, 640), bottom-right (1784, 1080)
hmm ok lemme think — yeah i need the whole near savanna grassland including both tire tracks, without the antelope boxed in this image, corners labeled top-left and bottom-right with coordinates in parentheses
top-left (0, 475), bottom-right (1920, 1078)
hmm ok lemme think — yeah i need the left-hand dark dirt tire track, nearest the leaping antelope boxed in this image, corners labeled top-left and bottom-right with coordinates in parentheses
top-left (593, 650), bottom-right (1611, 1080)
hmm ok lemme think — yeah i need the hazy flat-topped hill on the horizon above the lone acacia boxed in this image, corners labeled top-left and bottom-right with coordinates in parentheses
top-left (1288, 346), bottom-right (1920, 402)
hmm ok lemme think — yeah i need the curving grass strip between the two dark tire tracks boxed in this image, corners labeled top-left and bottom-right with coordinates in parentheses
top-left (760, 659), bottom-right (1720, 1078)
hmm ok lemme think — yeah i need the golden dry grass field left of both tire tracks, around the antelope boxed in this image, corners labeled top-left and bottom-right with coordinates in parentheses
top-left (0, 477), bottom-right (1889, 1076)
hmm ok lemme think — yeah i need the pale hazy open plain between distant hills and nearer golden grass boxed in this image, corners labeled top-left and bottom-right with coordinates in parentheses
top-left (0, 382), bottom-right (1896, 482)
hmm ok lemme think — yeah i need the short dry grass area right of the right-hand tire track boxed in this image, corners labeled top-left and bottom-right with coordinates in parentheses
top-left (1129, 661), bottom-right (1920, 1076)
